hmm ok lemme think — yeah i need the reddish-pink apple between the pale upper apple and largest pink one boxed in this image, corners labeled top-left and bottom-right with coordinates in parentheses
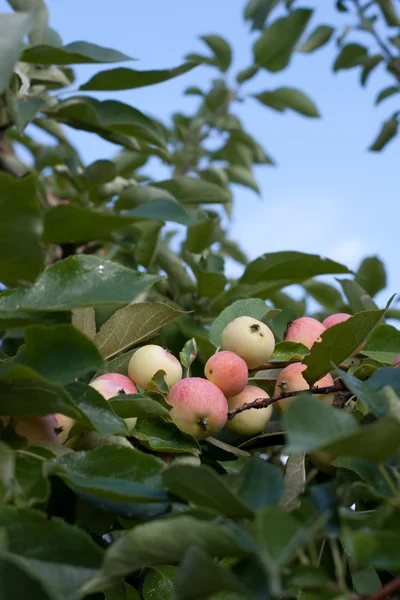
top-left (204, 350), bottom-right (249, 397)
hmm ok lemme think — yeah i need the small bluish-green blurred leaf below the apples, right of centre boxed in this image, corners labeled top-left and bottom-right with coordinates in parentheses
top-left (238, 456), bottom-right (283, 510)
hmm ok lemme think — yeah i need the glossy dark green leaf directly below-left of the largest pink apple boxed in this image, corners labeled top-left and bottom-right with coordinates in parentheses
top-left (132, 418), bottom-right (200, 454)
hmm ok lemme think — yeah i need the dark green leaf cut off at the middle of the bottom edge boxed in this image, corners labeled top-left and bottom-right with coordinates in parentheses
top-left (175, 546), bottom-right (248, 600)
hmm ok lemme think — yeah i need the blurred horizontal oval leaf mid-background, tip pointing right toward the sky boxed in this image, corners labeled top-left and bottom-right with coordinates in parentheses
top-left (153, 177), bottom-right (231, 204)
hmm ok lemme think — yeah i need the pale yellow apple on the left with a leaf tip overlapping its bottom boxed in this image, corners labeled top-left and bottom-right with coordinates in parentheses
top-left (128, 344), bottom-right (182, 389)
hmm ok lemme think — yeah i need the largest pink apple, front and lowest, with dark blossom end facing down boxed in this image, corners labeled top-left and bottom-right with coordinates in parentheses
top-left (167, 377), bottom-right (228, 440)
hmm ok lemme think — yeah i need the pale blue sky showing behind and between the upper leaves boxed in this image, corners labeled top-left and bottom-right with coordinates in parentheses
top-left (0, 0), bottom-right (400, 308)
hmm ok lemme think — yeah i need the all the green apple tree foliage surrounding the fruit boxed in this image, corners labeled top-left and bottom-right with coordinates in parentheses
top-left (0, 0), bottom-right (400, 600)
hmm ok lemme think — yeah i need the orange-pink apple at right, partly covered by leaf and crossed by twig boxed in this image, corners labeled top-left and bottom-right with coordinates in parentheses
top-left (274, 363), bottom-right (335, 410)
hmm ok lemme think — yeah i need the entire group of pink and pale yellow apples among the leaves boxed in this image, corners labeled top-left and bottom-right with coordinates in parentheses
top-left (3, 313), bottom-right (358, 447)
